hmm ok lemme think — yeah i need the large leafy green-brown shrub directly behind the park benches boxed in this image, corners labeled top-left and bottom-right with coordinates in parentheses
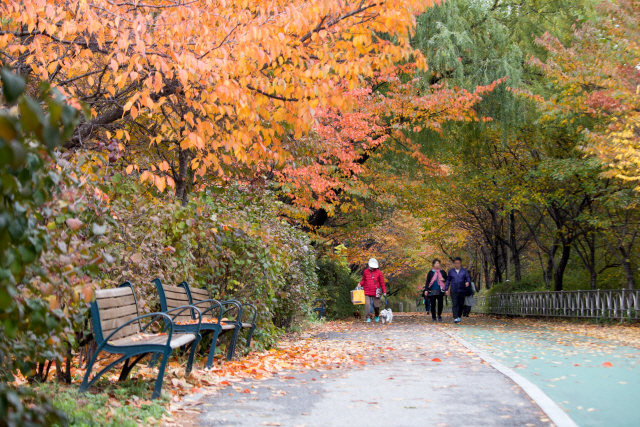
top-left (104, 179), bottom-right (317, 349)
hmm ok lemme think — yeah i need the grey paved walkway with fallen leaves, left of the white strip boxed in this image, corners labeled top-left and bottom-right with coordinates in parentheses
top-left (200, 316), bottom-right (551, 427)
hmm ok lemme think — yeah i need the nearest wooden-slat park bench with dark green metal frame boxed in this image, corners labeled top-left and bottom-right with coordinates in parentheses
top-left (80, 282), bottom-right (202, 399)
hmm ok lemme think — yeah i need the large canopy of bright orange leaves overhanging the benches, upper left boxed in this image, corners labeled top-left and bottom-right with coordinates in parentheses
top-left (0, 0), bottom-right (433, 190)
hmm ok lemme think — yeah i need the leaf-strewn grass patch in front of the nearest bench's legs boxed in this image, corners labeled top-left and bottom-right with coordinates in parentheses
top-left (36, 381), bottom-right (168, 427)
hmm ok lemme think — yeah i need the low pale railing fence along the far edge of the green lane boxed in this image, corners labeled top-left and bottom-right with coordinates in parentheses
top-left (474, 289), bottom-right (640, 319)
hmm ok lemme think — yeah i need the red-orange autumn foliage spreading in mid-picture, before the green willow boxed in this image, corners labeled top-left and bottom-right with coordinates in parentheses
top-left (275, 69), bottom-right (506, 213)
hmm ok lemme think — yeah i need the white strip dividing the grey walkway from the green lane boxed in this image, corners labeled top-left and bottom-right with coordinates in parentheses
top-left (444, 331), bottom-right (578, 427)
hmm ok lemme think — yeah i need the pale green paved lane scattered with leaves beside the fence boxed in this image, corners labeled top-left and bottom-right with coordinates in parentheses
top-left (449, 319), bottom-right (640, 427)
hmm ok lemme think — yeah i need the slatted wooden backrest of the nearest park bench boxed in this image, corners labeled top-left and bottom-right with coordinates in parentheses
top-left (91, 282), bottom-right (140, 343)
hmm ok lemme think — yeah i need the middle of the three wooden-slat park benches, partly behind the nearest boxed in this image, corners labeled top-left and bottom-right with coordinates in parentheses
top-left (152, 279), bottom-right (242, 368)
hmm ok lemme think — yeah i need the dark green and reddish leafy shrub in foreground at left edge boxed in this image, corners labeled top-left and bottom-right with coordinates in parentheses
top-left (0, 70), bottom-right (109, 426)
